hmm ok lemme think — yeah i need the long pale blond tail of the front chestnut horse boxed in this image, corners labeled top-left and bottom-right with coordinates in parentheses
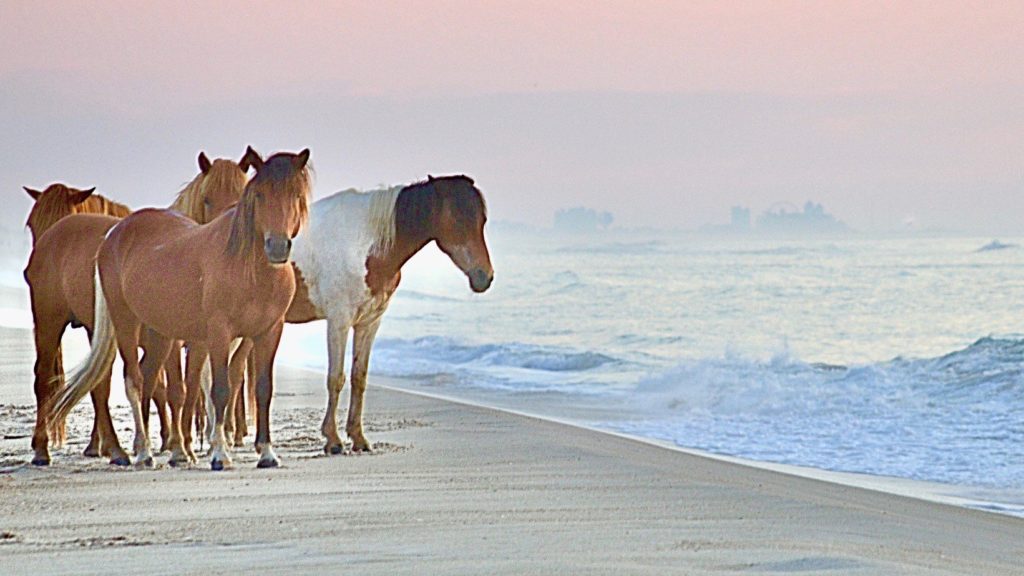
top-left (49, 269), bottom-right (118, 426)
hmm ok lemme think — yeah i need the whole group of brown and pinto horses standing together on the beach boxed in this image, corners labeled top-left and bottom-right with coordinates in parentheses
top-left (25, 147), bottom-right (494, 470)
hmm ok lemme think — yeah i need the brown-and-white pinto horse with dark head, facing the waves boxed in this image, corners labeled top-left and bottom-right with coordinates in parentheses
top-left (286, 175), bottom-right (495, 454)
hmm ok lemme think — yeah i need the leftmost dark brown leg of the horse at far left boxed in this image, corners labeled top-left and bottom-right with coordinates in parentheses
top-left (32, 314), bottom-right (67, 466)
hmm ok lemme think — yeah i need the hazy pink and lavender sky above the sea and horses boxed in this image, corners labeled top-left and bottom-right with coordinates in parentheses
top-left (0, 0), bottom-right (1024, 230)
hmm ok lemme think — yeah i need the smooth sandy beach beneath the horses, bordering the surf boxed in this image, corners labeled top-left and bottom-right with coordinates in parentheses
top-left (0, 323), bottom-right (1024, 575)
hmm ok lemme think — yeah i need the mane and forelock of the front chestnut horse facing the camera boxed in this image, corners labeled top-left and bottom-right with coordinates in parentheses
top-left (225, 153), bottom-right (312, 270)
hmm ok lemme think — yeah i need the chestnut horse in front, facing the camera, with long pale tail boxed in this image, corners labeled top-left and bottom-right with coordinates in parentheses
top-left (49, 147), bottom-right (310, 470)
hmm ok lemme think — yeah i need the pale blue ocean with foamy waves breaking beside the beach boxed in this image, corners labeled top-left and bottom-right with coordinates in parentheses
top-left (6, 232), bottom-right (1024, 515)
